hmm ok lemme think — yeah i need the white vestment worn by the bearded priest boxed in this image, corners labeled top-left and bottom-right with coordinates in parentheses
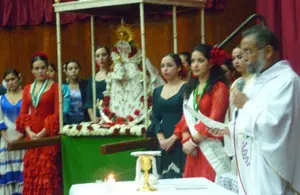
top-left (229, 61), bottom-right (300, 195)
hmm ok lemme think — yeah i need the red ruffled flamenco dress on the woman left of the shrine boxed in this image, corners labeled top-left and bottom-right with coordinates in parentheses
top-left (16, 83), bottom-right (62, 195)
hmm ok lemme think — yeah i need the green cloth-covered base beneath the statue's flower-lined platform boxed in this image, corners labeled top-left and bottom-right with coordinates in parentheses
top-left (61, 136), bottom-right (143, 195)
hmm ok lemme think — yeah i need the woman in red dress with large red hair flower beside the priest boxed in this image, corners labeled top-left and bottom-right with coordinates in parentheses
top-left (174, 44), bottom-right (229, 181)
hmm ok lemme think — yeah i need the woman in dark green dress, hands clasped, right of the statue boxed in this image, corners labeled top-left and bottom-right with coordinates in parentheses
top-left (151, 54), bottom-right (185, 178)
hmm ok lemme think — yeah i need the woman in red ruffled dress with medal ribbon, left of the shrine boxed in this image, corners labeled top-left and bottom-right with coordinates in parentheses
top-left (17, 53), bottom-right (62, 195)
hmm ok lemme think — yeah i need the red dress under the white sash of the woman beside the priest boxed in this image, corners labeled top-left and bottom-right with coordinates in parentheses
top-left (174, 82), bottom-right (229, 181)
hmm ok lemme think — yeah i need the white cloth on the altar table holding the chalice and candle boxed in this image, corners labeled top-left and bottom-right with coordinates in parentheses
top-left (69, 178), bottom-right (236, 195)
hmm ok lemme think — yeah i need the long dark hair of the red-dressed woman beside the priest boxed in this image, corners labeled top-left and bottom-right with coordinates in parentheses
top-left (184, 44), bottom-right (227, 99)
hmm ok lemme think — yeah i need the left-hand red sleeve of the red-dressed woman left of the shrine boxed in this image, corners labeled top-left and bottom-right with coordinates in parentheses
top-left (16, 85), bottom-right (31, 133)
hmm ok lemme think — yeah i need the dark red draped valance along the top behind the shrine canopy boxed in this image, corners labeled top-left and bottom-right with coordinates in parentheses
top-left (0, 0), bottom-right (226, 28)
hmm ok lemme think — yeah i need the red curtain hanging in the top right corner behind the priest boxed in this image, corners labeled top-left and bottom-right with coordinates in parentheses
top-left (257, 0), bottom-right (300, 74)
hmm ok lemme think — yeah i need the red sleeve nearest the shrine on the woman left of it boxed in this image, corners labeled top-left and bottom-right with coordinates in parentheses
top-left (44, 83), bottom-right (59, 136)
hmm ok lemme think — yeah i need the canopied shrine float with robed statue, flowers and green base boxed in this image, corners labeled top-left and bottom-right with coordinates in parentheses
top-left (54, 0), bottom-right (205, 194)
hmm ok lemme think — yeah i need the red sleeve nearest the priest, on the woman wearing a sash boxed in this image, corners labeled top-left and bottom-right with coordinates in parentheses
top-left (195, 82), bottom-right (229, 139)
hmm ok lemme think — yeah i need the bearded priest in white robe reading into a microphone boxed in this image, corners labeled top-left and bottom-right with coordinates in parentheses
top-left (210, 25), bottom-right (300, 195)
